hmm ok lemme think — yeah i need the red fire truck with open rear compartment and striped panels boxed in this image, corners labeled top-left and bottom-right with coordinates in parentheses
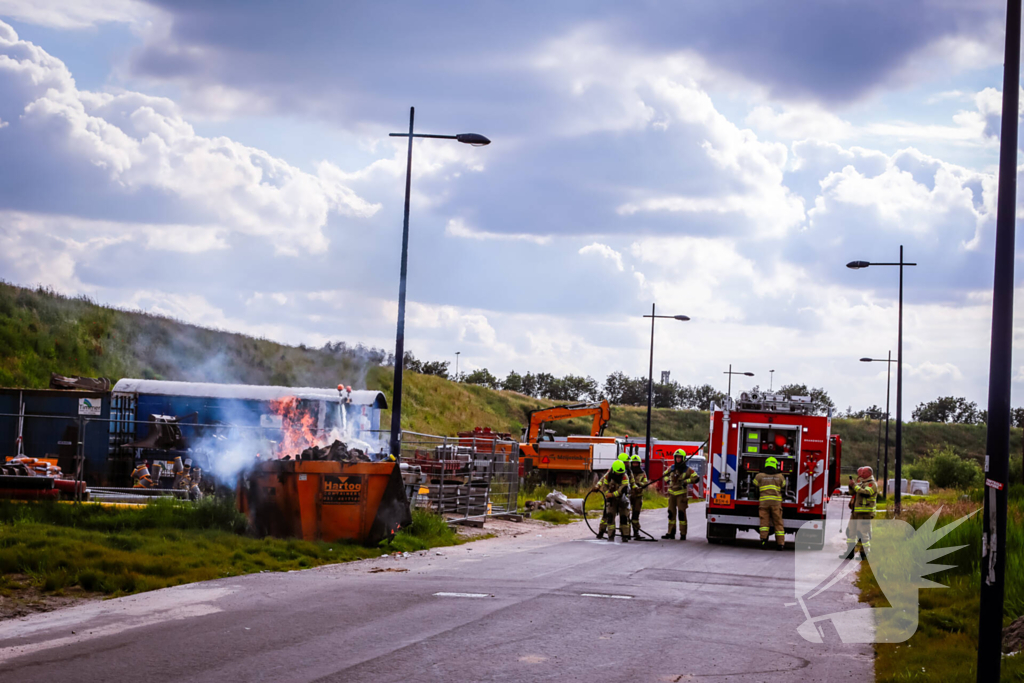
top-left (708, 393), bottom-right (842, 549)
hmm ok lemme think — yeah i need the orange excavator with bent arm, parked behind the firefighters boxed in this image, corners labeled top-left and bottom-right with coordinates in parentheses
top-left (519, 400), bottom-right (620, 482)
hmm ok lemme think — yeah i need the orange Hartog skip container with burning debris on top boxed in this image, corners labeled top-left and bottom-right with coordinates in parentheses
top-left (239, 460), bottom-right (413, 544)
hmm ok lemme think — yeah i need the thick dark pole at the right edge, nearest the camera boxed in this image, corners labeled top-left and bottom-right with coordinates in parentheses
top-left (978, 0), bottom-right (1021, 683)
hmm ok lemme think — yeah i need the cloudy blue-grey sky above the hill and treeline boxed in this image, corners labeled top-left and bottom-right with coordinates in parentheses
top-left (0, 0), bottom-right (1024, 411)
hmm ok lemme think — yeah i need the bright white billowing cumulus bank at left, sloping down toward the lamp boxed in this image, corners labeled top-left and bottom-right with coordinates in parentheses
top-left (0, 23), bottom-right (380, 254)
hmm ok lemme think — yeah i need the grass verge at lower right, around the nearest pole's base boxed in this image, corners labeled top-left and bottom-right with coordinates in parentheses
top-left (857, 485), bottom-right (1024, 683)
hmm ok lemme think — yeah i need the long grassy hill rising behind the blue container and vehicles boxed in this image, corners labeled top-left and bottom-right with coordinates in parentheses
top-left (0, 283), bottom-right (1022, 481)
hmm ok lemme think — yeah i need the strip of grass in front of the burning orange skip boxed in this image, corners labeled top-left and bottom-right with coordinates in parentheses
top-left (0, 499), bottom-right (464, 598)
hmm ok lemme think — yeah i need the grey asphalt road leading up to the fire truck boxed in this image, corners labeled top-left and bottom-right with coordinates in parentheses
top-left (0, 504), bottom-right (873, 683)
